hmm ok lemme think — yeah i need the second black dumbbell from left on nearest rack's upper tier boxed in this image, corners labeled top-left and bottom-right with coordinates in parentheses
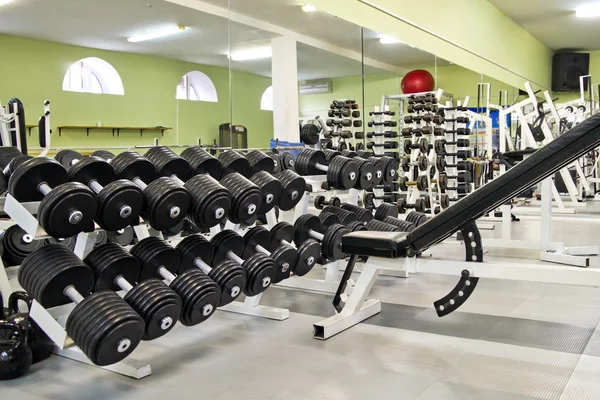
top-left (56, 156), bottom-right (144, 231)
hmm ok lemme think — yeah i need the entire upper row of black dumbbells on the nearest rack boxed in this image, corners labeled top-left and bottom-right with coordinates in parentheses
top-left (1, 147), bottom-right (306, 241)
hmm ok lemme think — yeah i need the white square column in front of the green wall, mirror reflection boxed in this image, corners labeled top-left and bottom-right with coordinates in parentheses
top-left (271, 36), bottom-right (300, 142)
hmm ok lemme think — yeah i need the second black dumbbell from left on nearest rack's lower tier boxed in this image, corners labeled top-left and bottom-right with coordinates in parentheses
top-left (83, 243), bottom-right (181, 340)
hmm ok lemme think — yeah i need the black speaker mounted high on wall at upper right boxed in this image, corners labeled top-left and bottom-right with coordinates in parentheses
top-left (552, 53), bottom-right (590, 92)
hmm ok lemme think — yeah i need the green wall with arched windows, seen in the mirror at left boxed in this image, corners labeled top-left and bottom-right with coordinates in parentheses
top-left (0, 35), bottom-right (273, 152)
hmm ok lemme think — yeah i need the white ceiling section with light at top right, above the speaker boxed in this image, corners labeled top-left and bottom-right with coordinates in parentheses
top-left (490, 0), bottom-right (600, 51)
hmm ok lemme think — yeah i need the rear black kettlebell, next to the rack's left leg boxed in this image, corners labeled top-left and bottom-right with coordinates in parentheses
top-left (0, 292), bottom-right (54, 364)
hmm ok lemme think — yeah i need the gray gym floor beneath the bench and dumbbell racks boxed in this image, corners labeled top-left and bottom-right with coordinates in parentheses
top-left (5, 211), bottom-right (600, 400)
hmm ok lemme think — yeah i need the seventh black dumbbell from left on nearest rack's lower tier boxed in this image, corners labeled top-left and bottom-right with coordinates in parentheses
top-left (268, 222), bottom-right (321, 276)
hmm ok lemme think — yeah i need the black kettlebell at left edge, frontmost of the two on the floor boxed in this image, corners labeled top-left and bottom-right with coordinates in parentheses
top-left (0, 321), bottom-right (33, 380)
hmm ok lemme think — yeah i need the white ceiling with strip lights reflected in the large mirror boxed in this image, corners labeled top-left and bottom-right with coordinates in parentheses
top-left (0, 0), bottom-right (433, 80)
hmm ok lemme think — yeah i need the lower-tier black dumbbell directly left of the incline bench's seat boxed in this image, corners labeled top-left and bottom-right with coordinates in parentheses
top-left (294, 214), bottom-right (350, 261)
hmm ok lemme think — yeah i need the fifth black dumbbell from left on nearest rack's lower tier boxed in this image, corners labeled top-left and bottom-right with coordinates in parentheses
top-left (211, 230), bottom-right (276, 297)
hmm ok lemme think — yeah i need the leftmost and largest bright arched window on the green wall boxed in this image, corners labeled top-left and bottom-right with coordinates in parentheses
top-left (63, 57), bottom-right (125, 96)
